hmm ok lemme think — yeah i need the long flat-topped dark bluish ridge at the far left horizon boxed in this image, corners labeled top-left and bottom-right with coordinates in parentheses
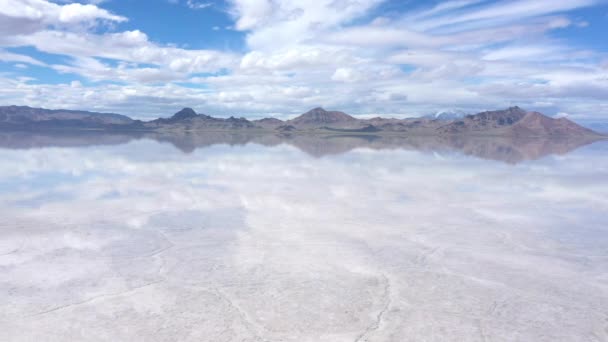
top-left (0, 106), bottom-right (133, 127)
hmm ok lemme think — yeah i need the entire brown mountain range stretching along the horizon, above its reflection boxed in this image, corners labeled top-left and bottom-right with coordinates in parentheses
top-left (0, 106), bottom-right (602, 138)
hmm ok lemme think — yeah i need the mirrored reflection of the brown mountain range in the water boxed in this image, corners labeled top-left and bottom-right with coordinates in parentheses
top-left (0, 131), bottom-right (597, 164)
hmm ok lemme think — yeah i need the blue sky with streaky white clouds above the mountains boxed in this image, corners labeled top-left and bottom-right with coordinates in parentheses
top-left (0, 0), bottom-right (608, 120)
